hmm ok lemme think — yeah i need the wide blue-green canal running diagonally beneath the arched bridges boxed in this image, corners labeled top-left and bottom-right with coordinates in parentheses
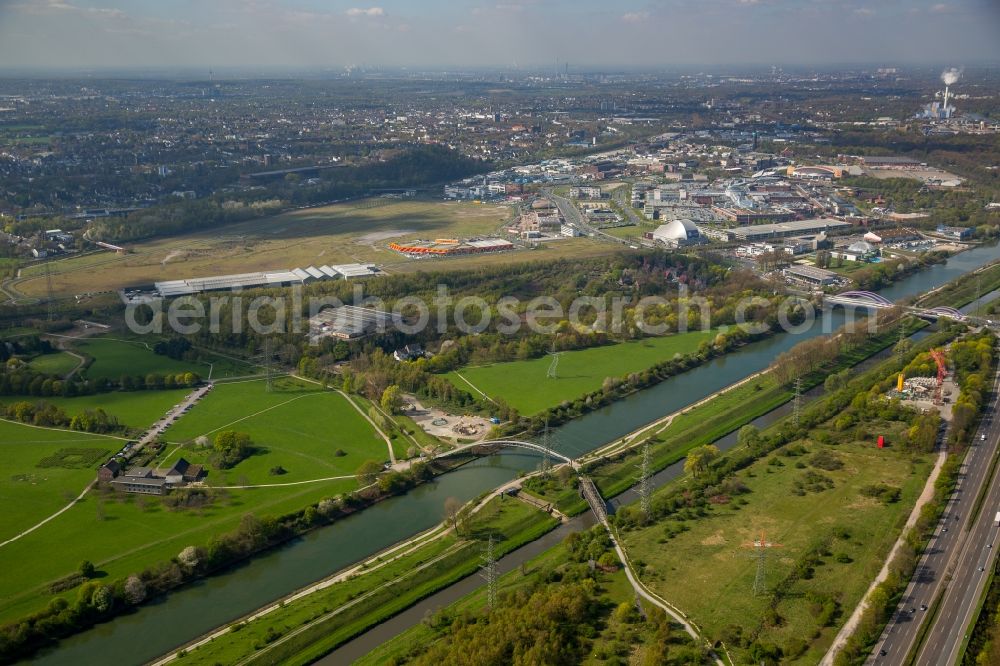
top-left (33, 245), bottom-right (1000, 666)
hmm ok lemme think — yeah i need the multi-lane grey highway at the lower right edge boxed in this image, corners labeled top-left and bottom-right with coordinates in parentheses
top-left (866, 358), bottom-right (1000, 666)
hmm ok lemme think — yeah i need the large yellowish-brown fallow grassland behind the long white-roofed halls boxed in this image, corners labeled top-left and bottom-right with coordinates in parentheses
top-left (17, 200), bottom-right (518, 295)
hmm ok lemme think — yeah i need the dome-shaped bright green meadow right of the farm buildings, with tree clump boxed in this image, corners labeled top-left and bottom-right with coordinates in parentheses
top-left (158, 379), bottom-right (389, 486)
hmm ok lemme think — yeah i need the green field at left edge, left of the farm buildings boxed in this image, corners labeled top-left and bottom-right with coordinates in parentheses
top-left (0, 421), bottom-right (122, 544)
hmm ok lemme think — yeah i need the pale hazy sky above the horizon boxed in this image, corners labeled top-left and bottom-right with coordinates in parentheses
top-left (0, 0), bottom-right (1000, 68)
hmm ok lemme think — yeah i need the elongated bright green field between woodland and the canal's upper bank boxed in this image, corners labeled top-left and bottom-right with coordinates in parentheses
top-left (447, 330), bottom-right (718, 415)
